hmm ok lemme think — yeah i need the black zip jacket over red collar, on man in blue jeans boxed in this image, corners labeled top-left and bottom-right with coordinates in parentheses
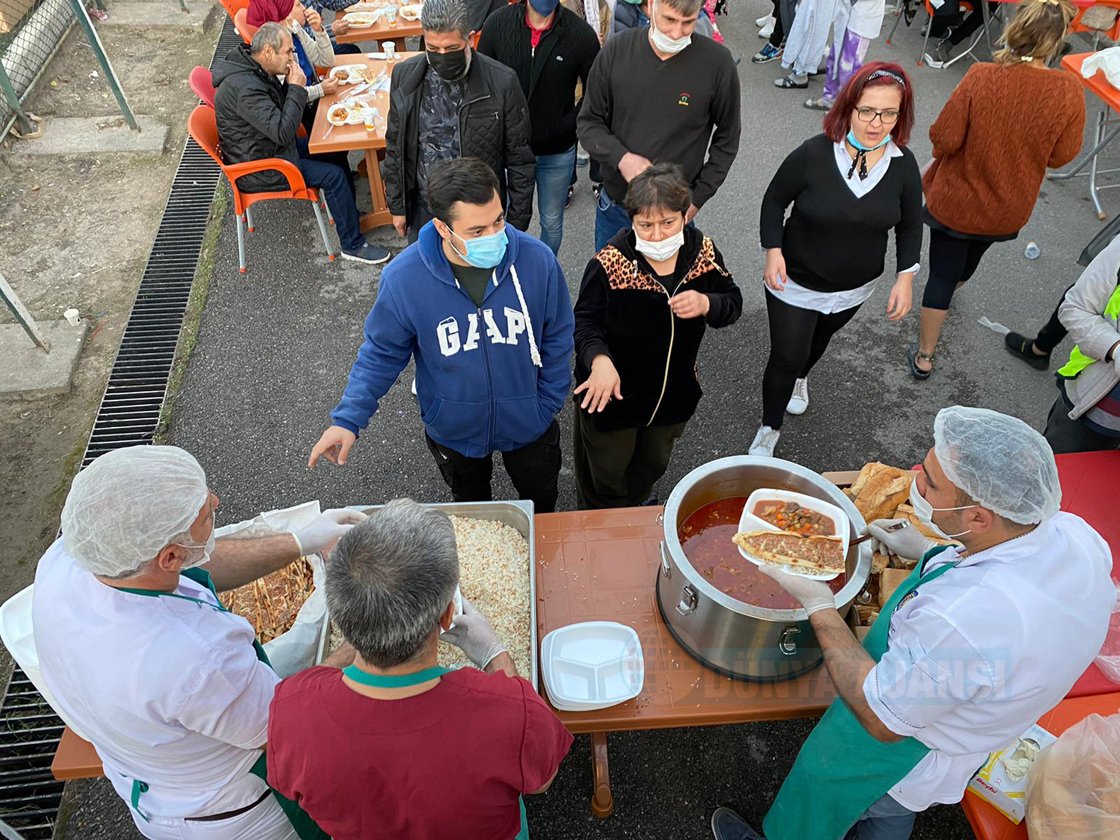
top-left (478, 3), bottom-right (599, 155)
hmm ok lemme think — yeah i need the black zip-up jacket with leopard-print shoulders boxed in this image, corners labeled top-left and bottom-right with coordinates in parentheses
top-left (575, 227), bottom-right (743, 431)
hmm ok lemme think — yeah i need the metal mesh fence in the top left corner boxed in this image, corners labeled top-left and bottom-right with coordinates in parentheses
top-left (0, 0), bottom-right (74, 139)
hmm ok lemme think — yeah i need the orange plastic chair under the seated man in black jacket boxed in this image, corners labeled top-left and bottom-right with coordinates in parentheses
top-left (187, 105), bottom-right (335, 274)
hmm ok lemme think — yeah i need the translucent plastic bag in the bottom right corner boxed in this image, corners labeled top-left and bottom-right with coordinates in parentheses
top-left (1027, 715), bottom-right (1120, 840)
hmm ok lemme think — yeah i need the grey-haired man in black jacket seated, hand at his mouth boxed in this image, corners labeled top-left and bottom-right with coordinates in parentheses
top-left (213, 24), bottom-right (390, 264)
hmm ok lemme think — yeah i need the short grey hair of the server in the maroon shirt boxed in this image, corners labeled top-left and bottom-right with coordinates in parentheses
top-left (327, 499), bottom-right (459, 668)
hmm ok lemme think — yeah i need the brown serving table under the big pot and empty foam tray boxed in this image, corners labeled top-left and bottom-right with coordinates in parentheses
top-left (535, 506), bottom-right (836, 818)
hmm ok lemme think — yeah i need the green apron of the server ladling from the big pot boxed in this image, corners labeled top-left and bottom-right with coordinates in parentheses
top-left (763, 545), bottom-right (956, 840)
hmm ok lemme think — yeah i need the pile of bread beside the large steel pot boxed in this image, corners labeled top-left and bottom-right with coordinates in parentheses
top-left (844, 461), bottom-right (951, 635)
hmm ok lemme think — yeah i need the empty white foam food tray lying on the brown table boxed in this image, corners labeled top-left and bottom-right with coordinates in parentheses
top-left (541, 622), bottom-right (645, 711)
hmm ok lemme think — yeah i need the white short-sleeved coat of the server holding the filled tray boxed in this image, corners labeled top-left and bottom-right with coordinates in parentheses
top-left (864, 513), bottom-right (1116, 811)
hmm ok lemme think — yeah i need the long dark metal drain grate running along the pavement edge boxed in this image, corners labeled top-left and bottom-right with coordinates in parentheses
top-left (0, 18), bottom-right (242, 840)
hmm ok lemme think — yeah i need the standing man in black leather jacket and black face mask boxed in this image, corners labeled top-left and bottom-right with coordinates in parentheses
top-left (383, 0), bottom-right (536, 242)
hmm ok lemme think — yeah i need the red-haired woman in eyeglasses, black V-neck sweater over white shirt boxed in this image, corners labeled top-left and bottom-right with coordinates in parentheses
top-left (749, 62), bottom-right (922, 456)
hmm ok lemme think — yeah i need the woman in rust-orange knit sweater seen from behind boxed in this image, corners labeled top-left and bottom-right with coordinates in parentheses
top-left (907, 0), bottom-right (1085, 380)
